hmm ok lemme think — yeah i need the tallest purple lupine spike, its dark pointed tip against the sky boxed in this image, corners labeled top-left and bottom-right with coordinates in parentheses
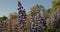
top-left (18, 1), bottom-right (26, 31)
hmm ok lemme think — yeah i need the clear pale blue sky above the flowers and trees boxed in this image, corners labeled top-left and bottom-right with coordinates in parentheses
top-left (0, 0), bottom-right (52, 17)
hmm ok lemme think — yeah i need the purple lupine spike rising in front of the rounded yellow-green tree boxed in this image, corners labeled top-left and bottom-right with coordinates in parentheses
top-left (36, 4), bottom-right (46, 31)
